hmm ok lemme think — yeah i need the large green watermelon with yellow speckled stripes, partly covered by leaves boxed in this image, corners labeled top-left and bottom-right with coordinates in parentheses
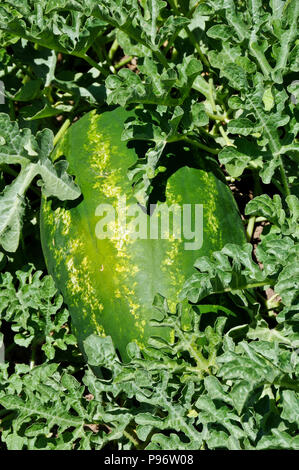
top-left (41, 108), bottom-right (245, 360)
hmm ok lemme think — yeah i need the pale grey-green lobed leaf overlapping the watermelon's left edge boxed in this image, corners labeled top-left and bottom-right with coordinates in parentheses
top-left (0, 114), bottom-right (80, 252)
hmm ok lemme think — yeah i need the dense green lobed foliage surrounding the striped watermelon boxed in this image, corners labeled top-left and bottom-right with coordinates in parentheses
top-left (0, 0), bottom-right (299, 449)
